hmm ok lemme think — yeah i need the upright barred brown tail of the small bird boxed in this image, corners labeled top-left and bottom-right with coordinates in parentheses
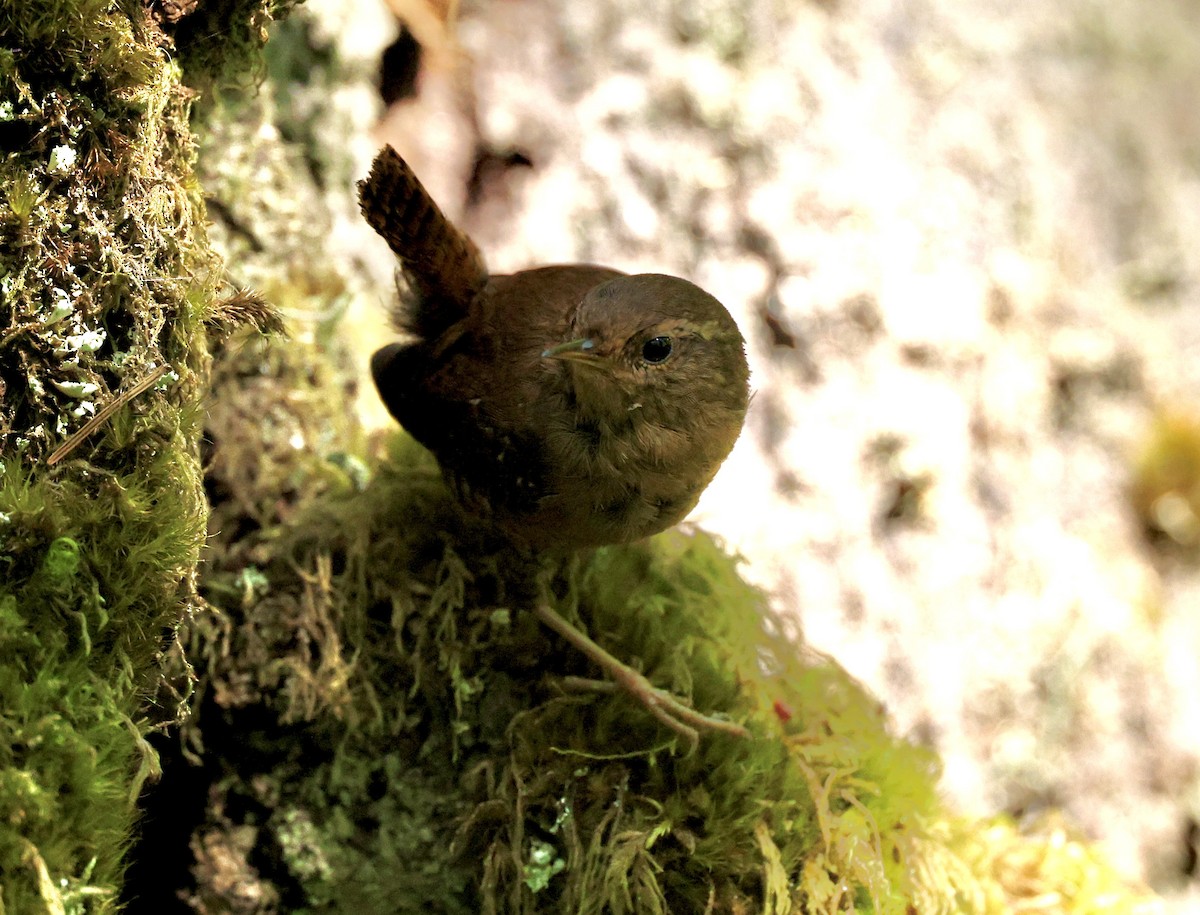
top-left (358, 146), bottom-right (487, 340)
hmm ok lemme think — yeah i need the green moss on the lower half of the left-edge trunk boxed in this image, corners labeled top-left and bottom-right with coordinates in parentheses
top-left (0, 398), bottom-right (204, 913)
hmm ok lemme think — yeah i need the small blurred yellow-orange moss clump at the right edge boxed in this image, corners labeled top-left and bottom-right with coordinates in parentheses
top-left (1130, 409), bottom-right (1200, 548)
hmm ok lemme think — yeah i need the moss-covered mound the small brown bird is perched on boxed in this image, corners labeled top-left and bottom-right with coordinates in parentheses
top-left (174, 410), bottom-right (1156, 915)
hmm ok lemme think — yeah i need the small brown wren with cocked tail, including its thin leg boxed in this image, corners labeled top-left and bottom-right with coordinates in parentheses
top-left (359, 146), bottom-right (749, 736)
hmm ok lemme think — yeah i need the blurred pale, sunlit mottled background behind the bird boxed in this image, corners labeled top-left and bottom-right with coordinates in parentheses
top-left (200, 0), bottom-right (1200, 911)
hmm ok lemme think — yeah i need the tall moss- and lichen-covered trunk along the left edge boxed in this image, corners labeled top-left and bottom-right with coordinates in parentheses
top-left (0, 0), bottom-right (288, 915)
